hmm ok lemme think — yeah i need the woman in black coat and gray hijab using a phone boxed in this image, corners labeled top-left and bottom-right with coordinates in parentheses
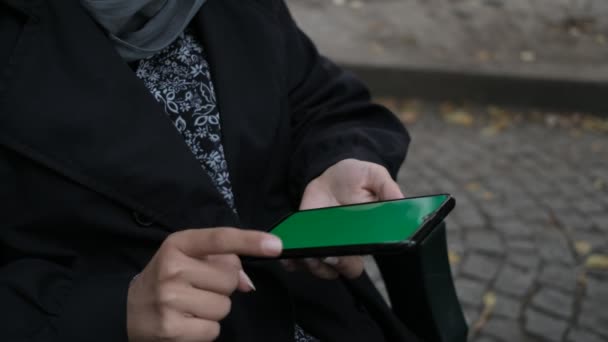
top-left (0, 0), bottom-right (413, 341)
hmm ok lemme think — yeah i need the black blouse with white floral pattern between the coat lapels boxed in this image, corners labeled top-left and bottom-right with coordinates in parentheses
top-left (136, 31), bottom-right (235, 210)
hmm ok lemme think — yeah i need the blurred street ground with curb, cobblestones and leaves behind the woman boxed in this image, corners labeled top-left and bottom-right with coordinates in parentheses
top-left (288, 0), bottom-right (608, 342)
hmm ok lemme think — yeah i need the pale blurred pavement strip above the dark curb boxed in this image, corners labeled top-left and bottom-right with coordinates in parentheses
top-left (288, 0), bottom-right (608, 81)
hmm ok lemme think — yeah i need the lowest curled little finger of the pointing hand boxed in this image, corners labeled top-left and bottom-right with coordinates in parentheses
top-left (157, 311), bottom-right (220, 342)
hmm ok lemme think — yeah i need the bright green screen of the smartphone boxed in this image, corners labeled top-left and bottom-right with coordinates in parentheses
top-left (271, 195), bottom-right (449, 249)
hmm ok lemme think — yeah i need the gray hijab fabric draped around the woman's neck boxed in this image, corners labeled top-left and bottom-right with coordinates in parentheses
top-left (81, 0), bottom-right (206, 62)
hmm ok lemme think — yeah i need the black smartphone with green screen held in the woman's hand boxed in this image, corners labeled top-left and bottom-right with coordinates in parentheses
top-left (269, 194), bottom-right (455, 258)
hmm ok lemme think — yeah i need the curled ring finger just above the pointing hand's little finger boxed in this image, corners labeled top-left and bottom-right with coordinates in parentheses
top-left (159, 286), bottom-right (231, 321)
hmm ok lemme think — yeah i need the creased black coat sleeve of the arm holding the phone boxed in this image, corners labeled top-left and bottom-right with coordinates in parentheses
top-left (278, 0), bottom-right (410, 199)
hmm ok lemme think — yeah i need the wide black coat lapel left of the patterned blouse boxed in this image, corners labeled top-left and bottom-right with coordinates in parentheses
top-left (0, 0), bottom-right (235, 229)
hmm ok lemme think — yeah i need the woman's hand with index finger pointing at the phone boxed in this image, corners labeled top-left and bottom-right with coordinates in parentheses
top-left (127, 228), bottom-right (282, 342)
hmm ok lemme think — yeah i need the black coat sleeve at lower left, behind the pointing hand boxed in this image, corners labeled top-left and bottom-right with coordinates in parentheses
top-left (0, 258), bottom-right (134, 342)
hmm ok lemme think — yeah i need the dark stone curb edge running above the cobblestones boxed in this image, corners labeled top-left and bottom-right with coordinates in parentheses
top-left (341, 64), bottom-right (608, 115)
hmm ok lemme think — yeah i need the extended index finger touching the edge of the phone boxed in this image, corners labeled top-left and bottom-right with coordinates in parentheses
top-left (165, 228), bottom-right (283, 258)
